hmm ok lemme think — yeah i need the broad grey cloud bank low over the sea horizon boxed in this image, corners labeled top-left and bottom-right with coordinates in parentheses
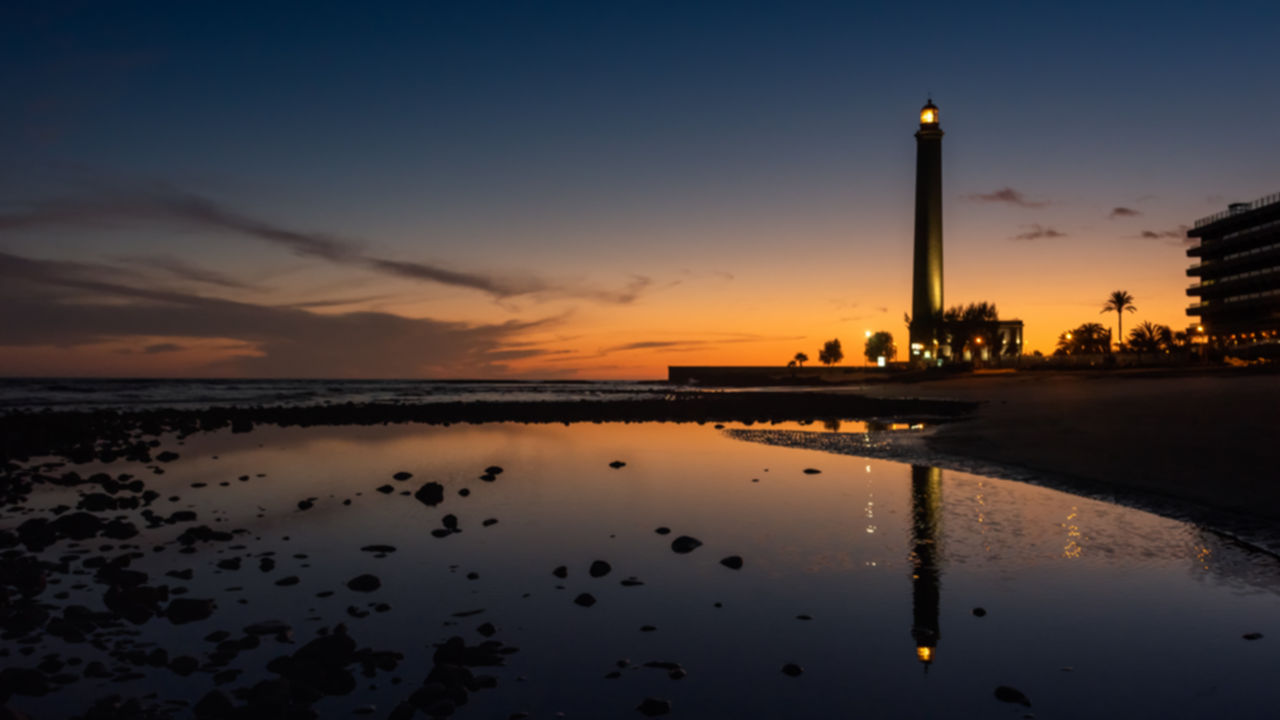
top-left (0, 252), bottom-right (553, 378)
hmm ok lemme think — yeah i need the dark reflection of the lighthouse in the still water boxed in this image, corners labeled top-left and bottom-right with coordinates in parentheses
top-left (910, 465), bottom-right (942, 667)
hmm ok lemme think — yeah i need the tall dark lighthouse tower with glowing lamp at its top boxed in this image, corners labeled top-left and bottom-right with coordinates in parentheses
top-left (909, 97), bottom-right (942, 363)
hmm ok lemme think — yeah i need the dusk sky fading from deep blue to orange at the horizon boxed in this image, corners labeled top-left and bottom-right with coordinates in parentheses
top-left (0, 0), bottom-right (1280, 379)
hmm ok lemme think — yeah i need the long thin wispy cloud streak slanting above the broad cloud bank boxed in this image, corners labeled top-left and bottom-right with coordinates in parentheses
top-left (0, 190), bottom-right (652, 304)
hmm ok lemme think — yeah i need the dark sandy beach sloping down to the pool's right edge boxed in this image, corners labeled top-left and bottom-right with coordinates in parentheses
top-left (867, 373), bottom-right (1280, 525)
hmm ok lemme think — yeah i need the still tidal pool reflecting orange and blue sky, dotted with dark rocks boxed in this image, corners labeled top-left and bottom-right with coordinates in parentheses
top-left (12, 424), bottom-right (1280, 719)
